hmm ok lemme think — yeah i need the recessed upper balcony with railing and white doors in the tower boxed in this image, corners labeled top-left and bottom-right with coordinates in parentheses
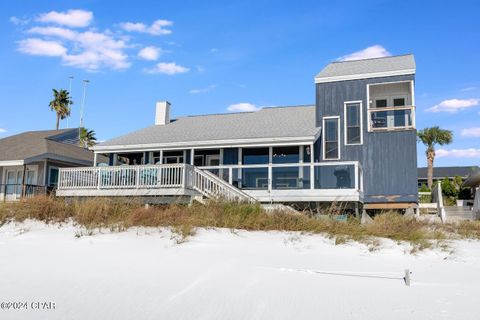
top-left (367, 81), bottom-right (415, 132)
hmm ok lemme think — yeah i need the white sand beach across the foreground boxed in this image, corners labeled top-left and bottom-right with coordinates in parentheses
top-left (0, 221), bottom-right (480, 320)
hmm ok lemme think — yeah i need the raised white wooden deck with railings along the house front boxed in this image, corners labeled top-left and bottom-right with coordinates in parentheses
top-left (56, 163), bottom-right (363, 202)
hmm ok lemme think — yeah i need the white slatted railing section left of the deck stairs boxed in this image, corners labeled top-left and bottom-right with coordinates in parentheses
top-left (58, 164), bottom-right (188, 190)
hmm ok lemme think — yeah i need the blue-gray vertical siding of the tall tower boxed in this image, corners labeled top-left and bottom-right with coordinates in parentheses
top-left (315, 75), bottom-right (417, 203)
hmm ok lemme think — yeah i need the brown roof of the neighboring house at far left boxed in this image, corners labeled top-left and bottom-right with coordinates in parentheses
top-left (0, 128), bottom-right (93, 163)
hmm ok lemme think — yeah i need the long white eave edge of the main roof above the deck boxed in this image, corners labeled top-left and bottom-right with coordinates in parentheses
top-left (90, 135), bottom-right (321, 153)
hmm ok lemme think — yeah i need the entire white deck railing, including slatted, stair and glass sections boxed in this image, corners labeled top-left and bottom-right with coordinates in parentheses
top-left (58, 161), bottom-right (363, 202)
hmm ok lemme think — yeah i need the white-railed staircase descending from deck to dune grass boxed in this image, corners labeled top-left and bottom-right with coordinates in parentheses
top-left (192, 166), bottom-right (257, 203)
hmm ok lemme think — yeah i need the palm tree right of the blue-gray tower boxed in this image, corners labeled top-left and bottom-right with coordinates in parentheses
top-left (417, 126), bottom-right (453, 189)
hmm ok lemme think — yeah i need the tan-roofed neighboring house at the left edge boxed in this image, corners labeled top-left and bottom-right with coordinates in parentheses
top-left (0, 128), bottom-right (98, 201)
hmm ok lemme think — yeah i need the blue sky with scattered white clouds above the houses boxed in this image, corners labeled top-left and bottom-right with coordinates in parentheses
top-left (0, 0), bottom-right (480, 165)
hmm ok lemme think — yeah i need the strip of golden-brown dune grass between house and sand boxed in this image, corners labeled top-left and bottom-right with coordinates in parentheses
top-left (0, 197), bottom-right (480, 251)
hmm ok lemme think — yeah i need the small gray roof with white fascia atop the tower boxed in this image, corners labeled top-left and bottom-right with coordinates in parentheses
top-left (315, 54), bottom-right (416, 83)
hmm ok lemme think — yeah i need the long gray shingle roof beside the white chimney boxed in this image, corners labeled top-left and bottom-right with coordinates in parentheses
top-left (96, 106), bottom-right (320, 150)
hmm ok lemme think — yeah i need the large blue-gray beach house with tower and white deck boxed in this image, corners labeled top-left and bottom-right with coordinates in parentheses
top-left (57, 55), bottom-right (417, 209)
